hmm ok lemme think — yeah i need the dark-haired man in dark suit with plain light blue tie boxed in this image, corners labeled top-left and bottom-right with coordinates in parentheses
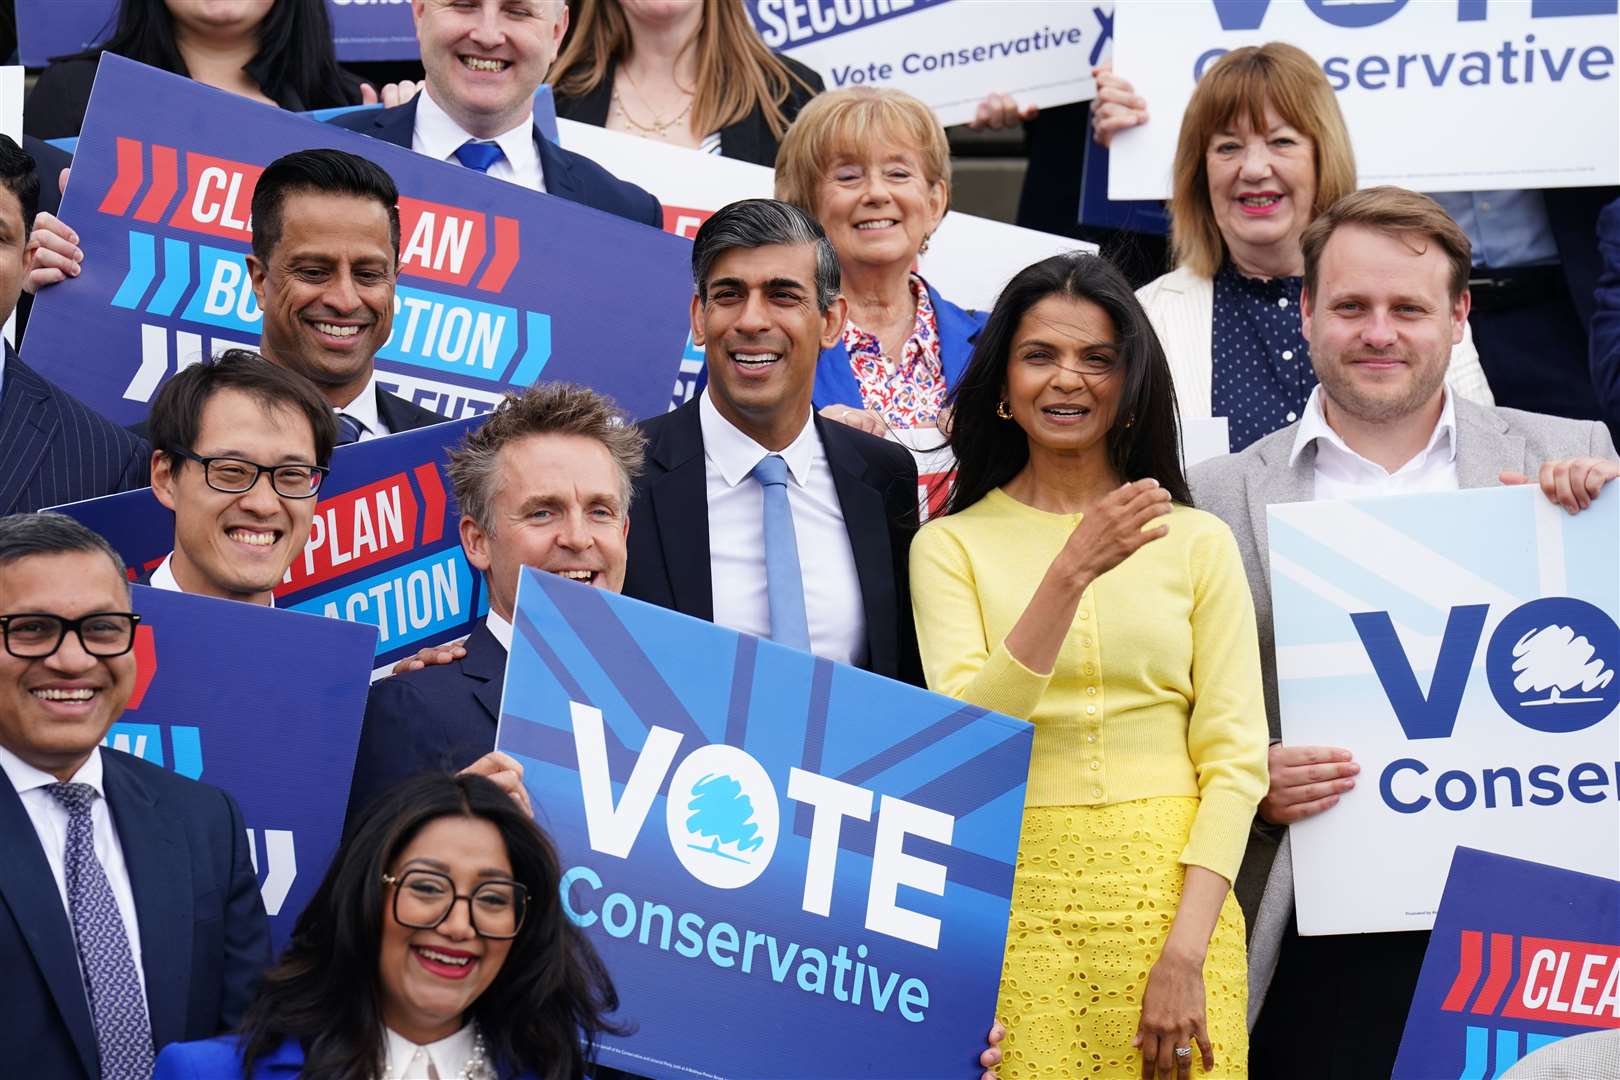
top-left (624, 199), bottom-right (922, 685)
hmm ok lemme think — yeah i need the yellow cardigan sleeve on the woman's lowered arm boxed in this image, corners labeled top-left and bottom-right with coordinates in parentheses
top-left (1181, 515), bottom-right (1268, 881)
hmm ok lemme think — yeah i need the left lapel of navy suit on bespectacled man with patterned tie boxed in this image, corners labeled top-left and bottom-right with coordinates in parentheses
top-left (0, 777), bottom-right (99, 1077)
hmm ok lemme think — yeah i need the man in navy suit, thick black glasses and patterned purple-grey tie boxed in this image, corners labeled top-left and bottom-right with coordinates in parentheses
top-left (0, 513), bottom-right (271, 1080)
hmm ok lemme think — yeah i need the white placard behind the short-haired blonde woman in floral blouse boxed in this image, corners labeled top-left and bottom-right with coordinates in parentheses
top-left (557, 120), bottom-right (1097, 309)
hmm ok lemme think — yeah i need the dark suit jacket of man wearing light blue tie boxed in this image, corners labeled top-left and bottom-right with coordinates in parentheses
top-left (624, 398), bottom-right (923, 687)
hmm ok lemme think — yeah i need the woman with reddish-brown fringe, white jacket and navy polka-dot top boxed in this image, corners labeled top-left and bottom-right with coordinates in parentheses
top-left (1092, 42), bottom-right (1494, 452)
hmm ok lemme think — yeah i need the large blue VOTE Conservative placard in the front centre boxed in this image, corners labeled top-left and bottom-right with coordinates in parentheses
top-left (496, 570), bottom-right (1034, 1080)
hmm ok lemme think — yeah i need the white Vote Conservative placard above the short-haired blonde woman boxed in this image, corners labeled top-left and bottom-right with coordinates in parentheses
top-left (747, 0), bottom-right (1113, 126)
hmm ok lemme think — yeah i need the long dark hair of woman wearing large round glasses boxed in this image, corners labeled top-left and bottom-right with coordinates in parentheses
top-left (241, 774), bottom-right (622, 1080)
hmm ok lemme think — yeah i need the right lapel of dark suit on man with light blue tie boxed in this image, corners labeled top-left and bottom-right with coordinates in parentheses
top-left (815, 413), bottom-right (909, 672)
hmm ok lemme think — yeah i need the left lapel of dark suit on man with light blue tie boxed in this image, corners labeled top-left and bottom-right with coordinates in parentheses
top-left (644, 400), bottom-right (714, 622)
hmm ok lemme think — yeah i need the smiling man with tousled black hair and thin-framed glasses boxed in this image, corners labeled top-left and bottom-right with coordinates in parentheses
top-left (147, 348), bottom-right (337, 604)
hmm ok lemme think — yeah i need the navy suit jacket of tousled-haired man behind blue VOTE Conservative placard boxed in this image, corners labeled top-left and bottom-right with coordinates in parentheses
top-left (343, 623), bottom-right (507, 834)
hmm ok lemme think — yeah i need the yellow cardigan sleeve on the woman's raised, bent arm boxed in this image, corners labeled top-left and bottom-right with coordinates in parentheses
top-left (910, 521), bottom-right (1056, 721)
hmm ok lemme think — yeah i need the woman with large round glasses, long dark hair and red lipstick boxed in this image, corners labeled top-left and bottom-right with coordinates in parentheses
top-left (154, 776), bottom-right (619, 1080)
